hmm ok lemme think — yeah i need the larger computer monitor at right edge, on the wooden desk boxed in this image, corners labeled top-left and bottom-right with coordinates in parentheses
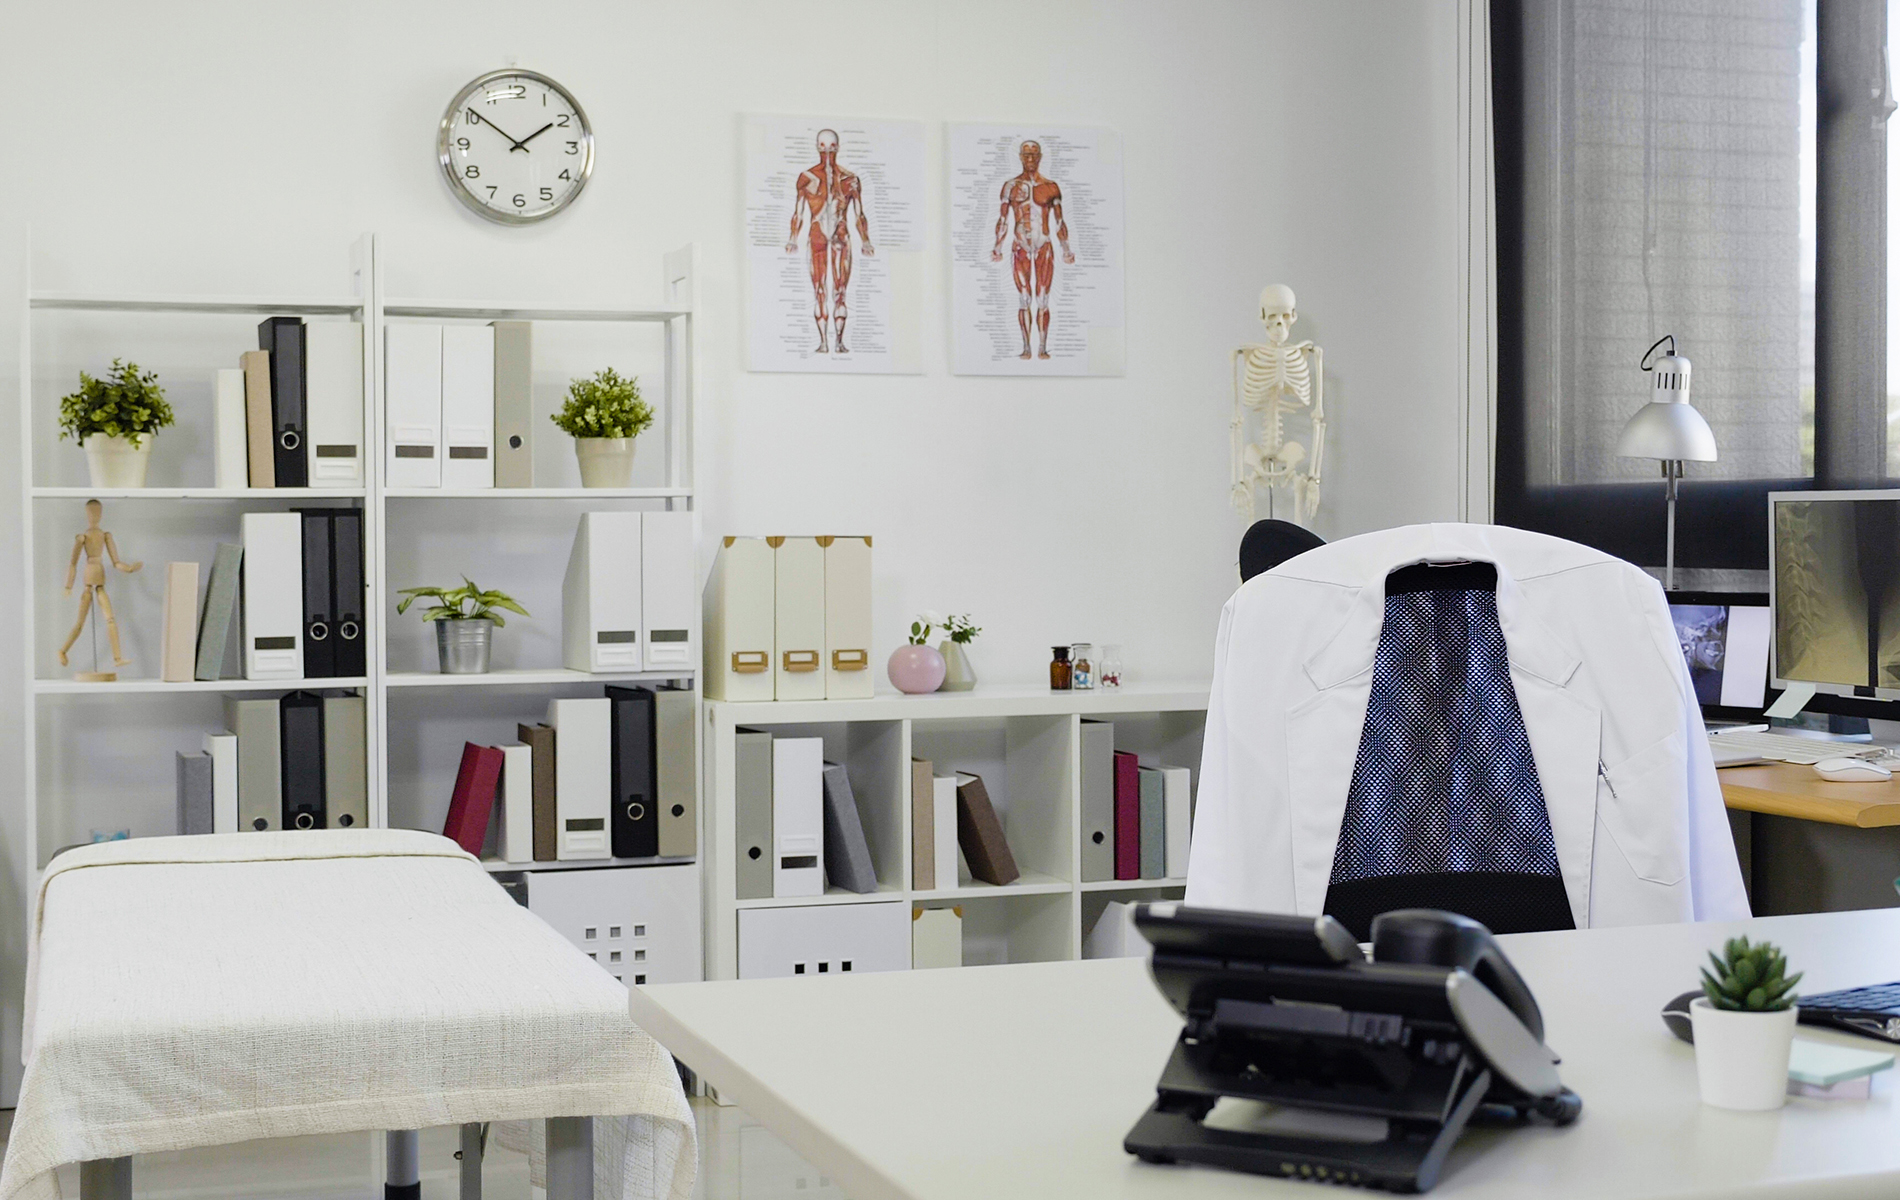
top-left (1769, 490), bottom-right (1900, 701)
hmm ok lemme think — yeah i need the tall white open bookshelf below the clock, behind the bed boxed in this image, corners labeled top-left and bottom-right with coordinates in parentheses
top-left (19, 234), bottom-right (697, 872)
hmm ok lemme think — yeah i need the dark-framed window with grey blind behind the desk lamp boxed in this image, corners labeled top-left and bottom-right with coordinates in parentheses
top-left (1492, 0), bottom-right (1900, 570)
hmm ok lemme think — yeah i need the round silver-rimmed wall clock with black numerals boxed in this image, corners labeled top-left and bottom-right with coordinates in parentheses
top-left (435, 70), bottom-right (593, 224)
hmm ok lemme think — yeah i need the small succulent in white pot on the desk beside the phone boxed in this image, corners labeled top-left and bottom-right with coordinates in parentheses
top-left (1689, 938), bottom-right (1801, 1113)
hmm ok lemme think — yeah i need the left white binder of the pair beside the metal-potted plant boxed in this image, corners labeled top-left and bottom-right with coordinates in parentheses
top-left (557, 513), bottom-right (640, 672)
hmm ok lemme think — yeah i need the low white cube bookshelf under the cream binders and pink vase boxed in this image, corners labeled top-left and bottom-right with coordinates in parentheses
top-left (701, 684), bottom-right (1207, 980)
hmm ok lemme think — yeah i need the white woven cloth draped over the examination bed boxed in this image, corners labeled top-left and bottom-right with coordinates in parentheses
top-left (0, 830), bottom-right (695, 1200)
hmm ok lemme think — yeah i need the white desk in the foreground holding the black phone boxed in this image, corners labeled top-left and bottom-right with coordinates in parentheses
top-left (631, 909), bottom-right (1900, 1200)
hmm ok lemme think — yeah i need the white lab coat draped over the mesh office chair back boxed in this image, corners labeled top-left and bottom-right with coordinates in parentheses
top-left (1188, 524), bottom-right (1748, 928)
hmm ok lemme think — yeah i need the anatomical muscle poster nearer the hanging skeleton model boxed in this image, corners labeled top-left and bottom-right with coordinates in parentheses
top-left (948, 125), bottom-right (1125, 376)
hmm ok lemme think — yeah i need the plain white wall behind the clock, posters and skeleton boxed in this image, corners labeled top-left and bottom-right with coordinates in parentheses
top-left (0, 0), bottom-right (1461, 1093)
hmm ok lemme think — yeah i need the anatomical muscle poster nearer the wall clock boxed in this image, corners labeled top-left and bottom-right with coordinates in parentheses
top-left (745, 116), bottom-right (923, 374)
